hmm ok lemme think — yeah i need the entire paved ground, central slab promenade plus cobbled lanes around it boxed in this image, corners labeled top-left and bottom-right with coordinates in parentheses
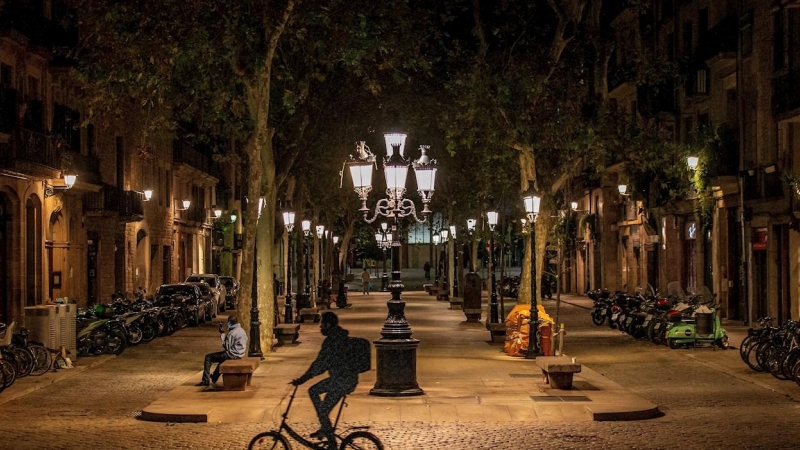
top-left (0, 271), bottom-right (800, 450)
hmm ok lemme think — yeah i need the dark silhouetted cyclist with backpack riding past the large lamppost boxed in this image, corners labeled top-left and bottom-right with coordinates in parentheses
top-left (291, 311), bottom-right (369, 443)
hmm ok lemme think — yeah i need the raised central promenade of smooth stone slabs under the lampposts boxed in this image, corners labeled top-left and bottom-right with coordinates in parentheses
top-left (141, 292), bottom-right (661, 423)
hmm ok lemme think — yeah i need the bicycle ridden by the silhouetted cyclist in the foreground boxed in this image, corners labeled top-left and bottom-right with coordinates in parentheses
top-left (247, 386), bottom-right (383, 450)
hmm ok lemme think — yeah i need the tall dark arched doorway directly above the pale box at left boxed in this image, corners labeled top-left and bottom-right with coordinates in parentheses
top-left (23, 195), bottom-right (44, 306)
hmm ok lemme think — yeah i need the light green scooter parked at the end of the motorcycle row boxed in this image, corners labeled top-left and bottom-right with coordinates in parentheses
top-left (667, 305), bottom-right (730, 349)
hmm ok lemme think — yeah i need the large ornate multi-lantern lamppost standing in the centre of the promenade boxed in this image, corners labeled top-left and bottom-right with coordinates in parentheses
top-left (340, 133), bottom-right (436, 397)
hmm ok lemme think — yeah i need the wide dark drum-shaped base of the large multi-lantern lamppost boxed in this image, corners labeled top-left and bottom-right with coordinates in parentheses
top-left (369, 338), bottom-right (425, 397)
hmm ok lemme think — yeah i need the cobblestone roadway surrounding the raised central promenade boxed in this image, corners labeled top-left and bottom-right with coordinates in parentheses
top-left (0, 290), bottom-right (800, 449)
